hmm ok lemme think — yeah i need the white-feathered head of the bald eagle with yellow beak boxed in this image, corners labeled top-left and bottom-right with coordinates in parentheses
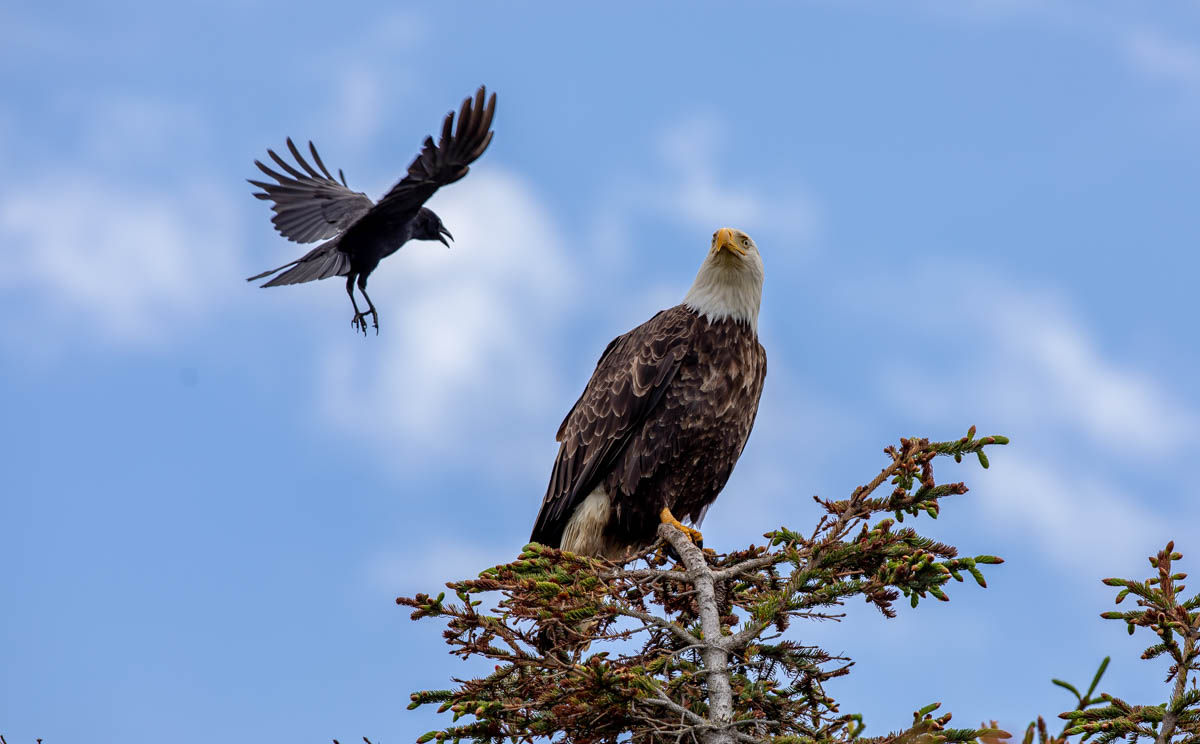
top-left (683, 227), bottom-right (763, 332)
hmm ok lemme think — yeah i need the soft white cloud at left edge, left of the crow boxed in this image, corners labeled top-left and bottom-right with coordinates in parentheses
top-left (0, 177), bottom-right (239, 343)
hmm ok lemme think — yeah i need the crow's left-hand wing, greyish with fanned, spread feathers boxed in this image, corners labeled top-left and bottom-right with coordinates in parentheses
top-left (247, 137), bottom-right (374, 242)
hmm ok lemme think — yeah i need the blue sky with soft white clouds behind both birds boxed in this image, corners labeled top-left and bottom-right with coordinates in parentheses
top-left (0, 0), bottom-right (1200, 744)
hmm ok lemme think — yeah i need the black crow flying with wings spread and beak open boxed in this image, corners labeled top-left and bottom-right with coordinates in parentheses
top-left (246, 85), bottom-right (496, 335)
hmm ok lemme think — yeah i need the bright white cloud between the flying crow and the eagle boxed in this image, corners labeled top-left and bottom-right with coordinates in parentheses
top-left (320, 168), bottom-right (577, 460)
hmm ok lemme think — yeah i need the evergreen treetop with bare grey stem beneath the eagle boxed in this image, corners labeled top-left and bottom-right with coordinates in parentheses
top-left (397, 428), bottom-right (1007, 744)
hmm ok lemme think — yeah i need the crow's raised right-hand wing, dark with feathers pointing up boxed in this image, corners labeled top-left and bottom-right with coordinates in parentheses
top-left (372, 85), bottom-right (496, 223)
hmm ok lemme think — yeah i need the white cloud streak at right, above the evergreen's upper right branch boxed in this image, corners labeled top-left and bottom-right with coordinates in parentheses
top-left (873, 270), bottom-right (1198, 460)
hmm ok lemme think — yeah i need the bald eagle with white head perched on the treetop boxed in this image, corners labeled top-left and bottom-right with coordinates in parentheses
top-left (530, 228), bottom-right (767, 559)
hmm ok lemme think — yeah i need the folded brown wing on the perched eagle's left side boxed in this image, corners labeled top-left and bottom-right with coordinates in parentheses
top-left (529, 305), bottom-right (696, 545)
